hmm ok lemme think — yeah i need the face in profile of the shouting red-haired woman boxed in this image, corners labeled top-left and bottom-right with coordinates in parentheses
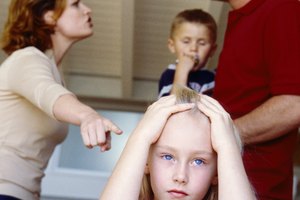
top-left (55, 0), bottom-right (93, 42)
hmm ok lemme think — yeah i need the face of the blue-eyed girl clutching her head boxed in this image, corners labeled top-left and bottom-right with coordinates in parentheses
top-left (146, 112), bottom-right (217, 200)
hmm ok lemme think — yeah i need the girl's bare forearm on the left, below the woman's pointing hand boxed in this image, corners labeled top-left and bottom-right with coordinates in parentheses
top-left (100, 133), bottom-right (150, 200)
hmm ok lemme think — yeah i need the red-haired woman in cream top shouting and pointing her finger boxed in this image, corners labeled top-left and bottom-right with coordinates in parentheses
top-left (0, 0), bottom-right (121, 200)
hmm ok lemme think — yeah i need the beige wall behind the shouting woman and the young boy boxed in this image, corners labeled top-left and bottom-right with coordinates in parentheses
top-left (0, 0), bottom-right (228, 104)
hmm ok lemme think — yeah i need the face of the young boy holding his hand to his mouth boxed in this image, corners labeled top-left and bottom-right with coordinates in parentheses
top-left (168, 22), bottom-right (216, 71)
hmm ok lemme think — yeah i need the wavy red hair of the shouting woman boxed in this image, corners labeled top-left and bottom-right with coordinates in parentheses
top-left (1, 0), bottom-right (66, 54)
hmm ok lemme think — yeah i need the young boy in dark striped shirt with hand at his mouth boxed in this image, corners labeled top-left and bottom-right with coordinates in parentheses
top-left (159, 9), bottom-right (217, 98)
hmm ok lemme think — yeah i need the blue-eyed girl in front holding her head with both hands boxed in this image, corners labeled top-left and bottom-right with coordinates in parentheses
top-left (100, 88), bottom-right (255, 200)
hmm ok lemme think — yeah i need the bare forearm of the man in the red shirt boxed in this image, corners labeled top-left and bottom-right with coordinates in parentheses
top-left (234, 95), bottom-right (300, 144)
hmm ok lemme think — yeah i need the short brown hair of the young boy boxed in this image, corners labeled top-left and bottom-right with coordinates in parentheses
top-left (170, 9), bottom-right (217, 43)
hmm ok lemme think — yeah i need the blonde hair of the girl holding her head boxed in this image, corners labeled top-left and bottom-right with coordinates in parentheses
top-left (139, 85), bottom-right (242, 200)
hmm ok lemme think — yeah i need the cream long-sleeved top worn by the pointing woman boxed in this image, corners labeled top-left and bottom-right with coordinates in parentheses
top-left (0, 47), bottom-right (71, 200)
